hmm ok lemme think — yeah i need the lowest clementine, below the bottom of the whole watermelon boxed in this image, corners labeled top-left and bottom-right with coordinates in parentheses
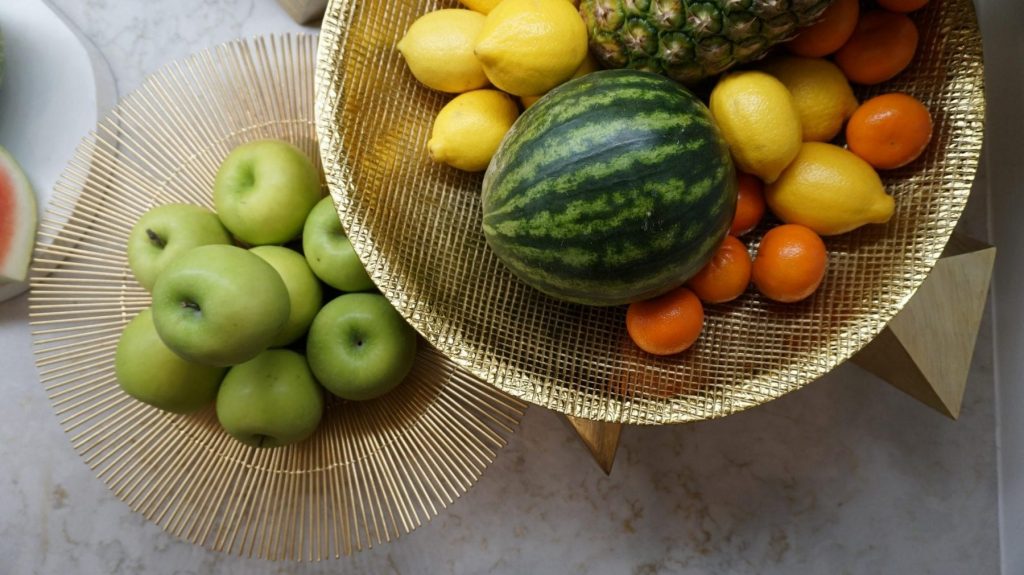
top-left (626, 288), bottom-right (703, 355)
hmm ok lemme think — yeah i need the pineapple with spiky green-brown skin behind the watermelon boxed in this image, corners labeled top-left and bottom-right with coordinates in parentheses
top-left (580, 0), bottom-right (833, 84)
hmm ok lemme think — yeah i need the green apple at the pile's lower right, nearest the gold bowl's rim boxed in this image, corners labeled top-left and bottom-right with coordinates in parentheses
top-left (306, 294), bottom-right (417, 400)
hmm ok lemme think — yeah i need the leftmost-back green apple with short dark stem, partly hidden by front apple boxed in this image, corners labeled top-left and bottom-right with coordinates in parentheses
top-left (128, 204), bottom-right (231, 292)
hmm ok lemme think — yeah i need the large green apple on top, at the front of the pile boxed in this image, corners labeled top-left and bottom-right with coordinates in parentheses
top-left (153, 246), bottom-right (291, 365)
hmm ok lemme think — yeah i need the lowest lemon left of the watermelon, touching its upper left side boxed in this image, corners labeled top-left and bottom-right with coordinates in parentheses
top-left (427, 90), bottom-right (519, 172)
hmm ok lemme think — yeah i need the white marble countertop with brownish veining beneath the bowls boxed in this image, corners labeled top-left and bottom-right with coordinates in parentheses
top-left (0, 0), bottom-right (999, 575)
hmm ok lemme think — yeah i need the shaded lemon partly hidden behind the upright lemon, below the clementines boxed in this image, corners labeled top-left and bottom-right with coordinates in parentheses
top-left (761, 56), bottom-right (857, 142)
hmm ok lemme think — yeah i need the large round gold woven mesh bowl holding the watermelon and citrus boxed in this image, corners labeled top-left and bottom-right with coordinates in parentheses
top-left (316, 0), bottom-right (984, 424)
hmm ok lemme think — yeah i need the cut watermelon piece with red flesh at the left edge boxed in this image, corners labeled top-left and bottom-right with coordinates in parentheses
top-left (0, 147), bottom-right (37, 283)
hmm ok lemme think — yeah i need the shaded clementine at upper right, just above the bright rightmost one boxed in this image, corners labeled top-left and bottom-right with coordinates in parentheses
top-left (836, 10), bottom-right (919, 85)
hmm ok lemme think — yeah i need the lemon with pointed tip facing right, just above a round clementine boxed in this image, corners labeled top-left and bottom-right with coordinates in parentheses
top-left (765, 142), bottom-right (895, 235)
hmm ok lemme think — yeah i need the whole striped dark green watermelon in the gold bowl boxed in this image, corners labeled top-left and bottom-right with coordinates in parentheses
top-left (482, 70), bottom-right (736, 306)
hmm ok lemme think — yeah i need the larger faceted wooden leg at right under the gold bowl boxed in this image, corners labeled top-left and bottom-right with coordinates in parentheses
top-left (853, 234), bottom-right (995, 419)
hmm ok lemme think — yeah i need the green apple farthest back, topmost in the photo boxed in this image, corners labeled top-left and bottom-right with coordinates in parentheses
top-left (213, 140), bottom-right (323, 246)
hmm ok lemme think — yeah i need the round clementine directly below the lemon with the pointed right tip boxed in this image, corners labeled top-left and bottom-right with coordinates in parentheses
top-left (751, 224), bottom-right (828, 303)
